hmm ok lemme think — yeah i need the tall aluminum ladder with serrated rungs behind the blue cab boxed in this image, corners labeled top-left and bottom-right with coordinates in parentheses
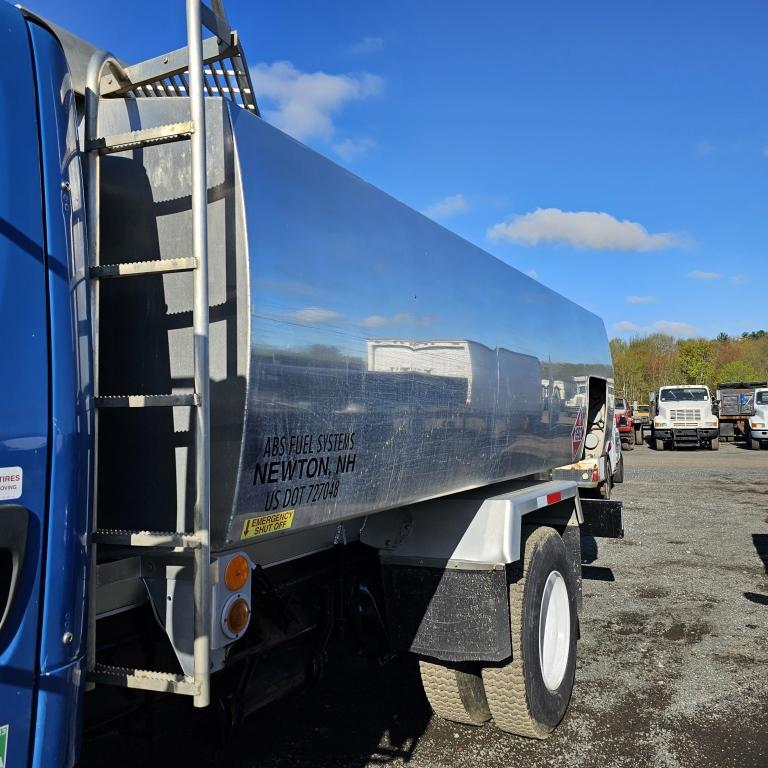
top-left (85, 0), bottom-right (254, 707)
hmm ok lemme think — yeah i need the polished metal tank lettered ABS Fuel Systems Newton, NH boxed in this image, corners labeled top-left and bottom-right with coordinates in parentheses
top-left (99, 98), bottom-right (611, 548)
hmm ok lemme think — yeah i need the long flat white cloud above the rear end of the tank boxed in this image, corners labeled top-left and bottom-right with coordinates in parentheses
top-left (487, 208), bottom-right (682, 251)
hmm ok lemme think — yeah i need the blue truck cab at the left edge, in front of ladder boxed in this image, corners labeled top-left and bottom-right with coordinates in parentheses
top-left (0, 3), bottom-right (92, 768)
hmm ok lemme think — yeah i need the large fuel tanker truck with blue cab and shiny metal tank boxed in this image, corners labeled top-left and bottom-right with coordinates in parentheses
top-left (0, 0), bottom-right (623, 768)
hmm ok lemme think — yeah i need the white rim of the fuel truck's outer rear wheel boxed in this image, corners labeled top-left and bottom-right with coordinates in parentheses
top-left (539, 571), bottom-right (571, 691)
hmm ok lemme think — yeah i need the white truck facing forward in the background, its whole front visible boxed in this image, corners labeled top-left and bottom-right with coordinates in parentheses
top-left (651, 384), bottom-right (720, 451)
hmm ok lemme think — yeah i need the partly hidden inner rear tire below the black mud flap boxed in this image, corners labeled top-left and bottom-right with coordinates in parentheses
top-left (419, 659), bottom-right (491, 725)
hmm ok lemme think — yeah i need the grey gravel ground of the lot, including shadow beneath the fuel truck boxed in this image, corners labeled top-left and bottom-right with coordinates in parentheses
top-left (79, 444), bottom-right (768, 768)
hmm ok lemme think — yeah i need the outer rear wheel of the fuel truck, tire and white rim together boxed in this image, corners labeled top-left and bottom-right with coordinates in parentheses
top-left (483, 526), bottom-right (577, 739)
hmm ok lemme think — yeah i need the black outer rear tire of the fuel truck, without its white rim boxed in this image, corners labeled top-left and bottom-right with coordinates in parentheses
top-left (483, 526), bottom-right (578, 739)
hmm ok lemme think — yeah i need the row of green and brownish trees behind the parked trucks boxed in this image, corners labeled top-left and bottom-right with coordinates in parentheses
top-left (611, 331), bottom-right (768, 403)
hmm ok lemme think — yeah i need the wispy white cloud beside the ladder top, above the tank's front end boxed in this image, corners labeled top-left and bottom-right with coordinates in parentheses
top-left (251, 61), bottom-right (384, 141)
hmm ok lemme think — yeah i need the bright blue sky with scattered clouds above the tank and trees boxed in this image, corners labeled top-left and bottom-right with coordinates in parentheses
top-left (28, 0), bottom-right (768, 336)
